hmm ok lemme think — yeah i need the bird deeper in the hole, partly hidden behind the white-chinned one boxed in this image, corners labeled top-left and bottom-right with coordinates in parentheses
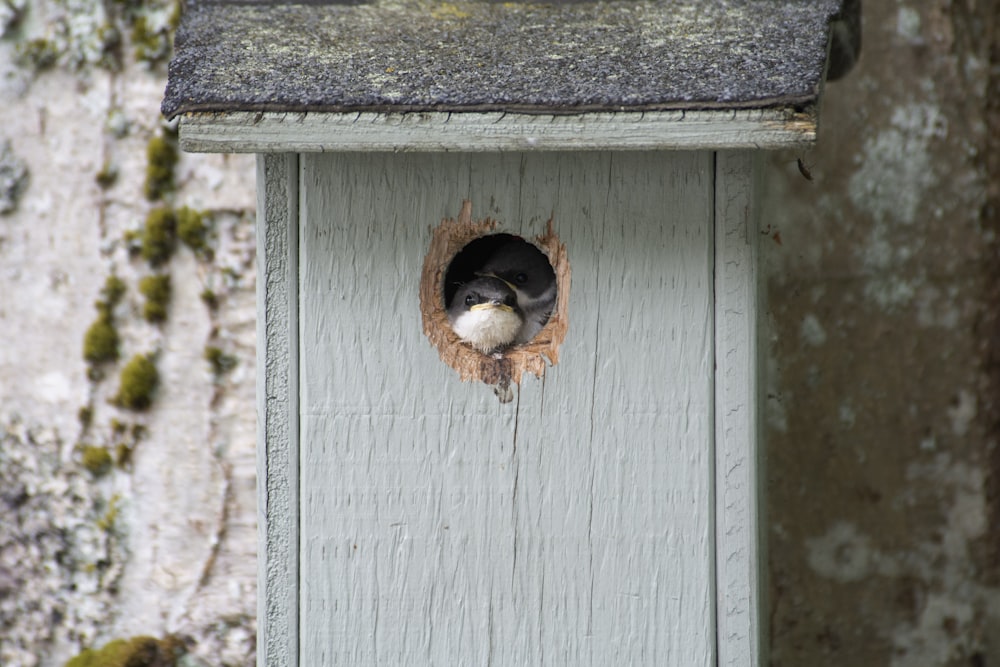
top-left (475, 237), bottom-right (556, 345)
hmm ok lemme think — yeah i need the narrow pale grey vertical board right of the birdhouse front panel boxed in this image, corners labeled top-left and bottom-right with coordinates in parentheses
top-left (715, 152), bottom-right (768, 667)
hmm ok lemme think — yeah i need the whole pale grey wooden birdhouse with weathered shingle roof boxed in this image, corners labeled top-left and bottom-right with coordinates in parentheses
top-left (163, 0), bottom-right (856, 666)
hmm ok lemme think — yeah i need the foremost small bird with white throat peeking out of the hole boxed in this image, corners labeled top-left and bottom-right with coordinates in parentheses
top-left (448, 276), bottom-right (524, 355)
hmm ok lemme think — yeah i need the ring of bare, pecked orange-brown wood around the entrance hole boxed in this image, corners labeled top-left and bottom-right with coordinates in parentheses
top-left (420, 199), bottom-right (570, 385)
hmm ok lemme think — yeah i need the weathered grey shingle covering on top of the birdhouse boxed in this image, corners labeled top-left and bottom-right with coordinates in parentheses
top-left (162, 0), bottom-right (860, 151)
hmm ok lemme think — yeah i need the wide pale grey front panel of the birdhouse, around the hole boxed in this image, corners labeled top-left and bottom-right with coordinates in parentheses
top-left (300, 152), bottom-right (716, 666)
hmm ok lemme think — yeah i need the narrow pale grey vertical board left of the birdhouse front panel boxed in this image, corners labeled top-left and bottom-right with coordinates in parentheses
top-left (257, 154), bottom-right (299, 667)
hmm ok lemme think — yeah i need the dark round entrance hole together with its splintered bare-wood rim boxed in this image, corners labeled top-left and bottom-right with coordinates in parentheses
top-left (420, 200), bottom-right (570, 394)
